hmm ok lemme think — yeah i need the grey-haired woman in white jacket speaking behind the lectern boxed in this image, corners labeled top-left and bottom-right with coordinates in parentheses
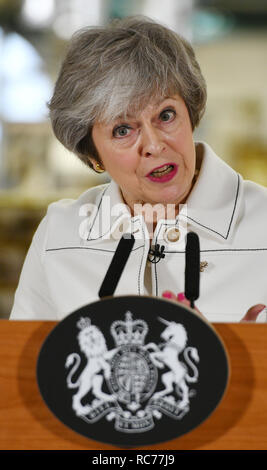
top-left (11, 17), bottom-right (267, 322)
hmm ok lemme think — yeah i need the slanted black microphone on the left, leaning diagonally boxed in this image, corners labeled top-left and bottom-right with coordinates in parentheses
top-left (98, 233), bottom-right (135, 299)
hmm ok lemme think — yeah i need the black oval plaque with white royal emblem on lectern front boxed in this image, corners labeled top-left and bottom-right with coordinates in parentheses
top-left (37, 296), bottom-right (229, 447)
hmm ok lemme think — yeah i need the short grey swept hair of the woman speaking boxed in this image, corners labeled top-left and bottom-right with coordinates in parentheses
top-left (48, 16), bottom-right (207, 167)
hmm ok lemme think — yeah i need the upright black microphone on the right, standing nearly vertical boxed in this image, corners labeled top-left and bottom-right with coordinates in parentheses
top-left (185, 232), bottom-right (200, 308)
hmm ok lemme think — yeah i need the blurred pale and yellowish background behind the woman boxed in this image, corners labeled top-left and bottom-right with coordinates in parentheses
top-left (0, 0), bottom-right (267, 318)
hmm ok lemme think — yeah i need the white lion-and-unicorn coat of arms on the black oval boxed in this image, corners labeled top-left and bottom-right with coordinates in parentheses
top-left (65, 312), bottom-right (199, 433)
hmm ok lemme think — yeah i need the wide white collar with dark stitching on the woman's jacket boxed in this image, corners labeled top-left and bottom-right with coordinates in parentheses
top-left (87, 142), bottom-right (243, 241)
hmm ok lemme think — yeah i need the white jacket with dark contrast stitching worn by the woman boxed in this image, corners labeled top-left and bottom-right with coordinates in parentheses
top-left (10, 144), bottom-right (267, 322)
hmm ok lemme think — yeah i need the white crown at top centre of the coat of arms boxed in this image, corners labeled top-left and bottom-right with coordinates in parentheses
top-left (110, 312), bottom-right (148, 346)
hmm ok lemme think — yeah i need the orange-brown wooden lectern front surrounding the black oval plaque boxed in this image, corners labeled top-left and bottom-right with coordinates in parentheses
top-left (0, 320), bottom-right (267, 450)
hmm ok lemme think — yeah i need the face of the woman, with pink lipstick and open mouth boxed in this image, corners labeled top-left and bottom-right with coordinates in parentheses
top-left (92, 95), bottom-right (196, 209)
